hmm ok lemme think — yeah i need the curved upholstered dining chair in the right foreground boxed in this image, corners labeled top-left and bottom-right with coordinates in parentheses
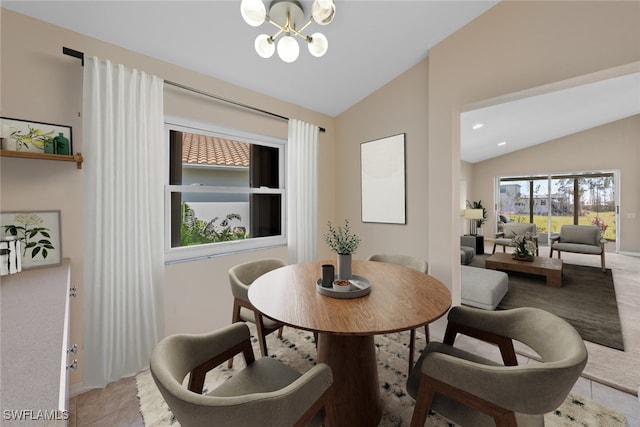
top-left (407, 306), bottom-right (587, 427)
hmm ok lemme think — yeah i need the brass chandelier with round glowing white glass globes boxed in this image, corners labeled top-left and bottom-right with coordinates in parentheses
top-left (240, 0), bottom-right (336, 62)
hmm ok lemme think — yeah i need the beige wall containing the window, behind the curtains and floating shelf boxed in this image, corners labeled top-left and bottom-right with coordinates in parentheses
top-left (0, 9), bottom-right (335, 392)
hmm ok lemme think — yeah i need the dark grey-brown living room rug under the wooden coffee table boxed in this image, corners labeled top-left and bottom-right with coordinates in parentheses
top-left (469, 255), bottom-right (624, 351)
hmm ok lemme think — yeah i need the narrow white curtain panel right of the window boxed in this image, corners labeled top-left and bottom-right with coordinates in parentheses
top-left (287, 119), bottom-right (319, 264)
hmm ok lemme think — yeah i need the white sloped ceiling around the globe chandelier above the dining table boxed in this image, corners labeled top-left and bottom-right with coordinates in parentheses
top-left (2, 0), bottom-right (497, 117)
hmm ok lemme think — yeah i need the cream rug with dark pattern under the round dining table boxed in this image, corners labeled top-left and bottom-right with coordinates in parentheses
top-left (136, 328), bottom-right (627, 427)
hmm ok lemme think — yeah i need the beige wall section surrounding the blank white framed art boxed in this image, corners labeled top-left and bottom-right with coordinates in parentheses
top-left (335, 60), bottom-right (428, 259)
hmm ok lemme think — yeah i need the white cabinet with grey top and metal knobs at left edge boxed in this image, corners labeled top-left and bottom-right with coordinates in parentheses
top-left (0, 259), bottom-right (77, 426)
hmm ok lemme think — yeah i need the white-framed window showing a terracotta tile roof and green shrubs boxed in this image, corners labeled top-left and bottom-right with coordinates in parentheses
top-left (165, 118), bottom-right (286, 262)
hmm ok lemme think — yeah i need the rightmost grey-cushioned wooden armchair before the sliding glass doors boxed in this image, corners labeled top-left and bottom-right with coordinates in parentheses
top-left (549, 225), bottom-right (607, 272)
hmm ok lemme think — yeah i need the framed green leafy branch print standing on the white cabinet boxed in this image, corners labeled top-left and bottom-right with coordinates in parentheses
top-left (0, 211), bottom-right (62, 270)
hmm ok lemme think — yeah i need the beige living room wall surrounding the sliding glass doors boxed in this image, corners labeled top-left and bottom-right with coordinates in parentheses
top-left (473, 116), bottom-right (640, 253)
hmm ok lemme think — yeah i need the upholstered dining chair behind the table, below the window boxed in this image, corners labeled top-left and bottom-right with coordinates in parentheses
top-left (229, 258), bottom-right (285, 367)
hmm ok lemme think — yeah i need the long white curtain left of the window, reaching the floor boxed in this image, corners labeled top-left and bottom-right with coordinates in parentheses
top-left (82, 57), bottom-right (166, 388)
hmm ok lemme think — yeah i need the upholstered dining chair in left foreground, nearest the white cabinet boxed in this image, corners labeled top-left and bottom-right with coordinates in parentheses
top-left (150, 322), bottom-right (335, 427)
